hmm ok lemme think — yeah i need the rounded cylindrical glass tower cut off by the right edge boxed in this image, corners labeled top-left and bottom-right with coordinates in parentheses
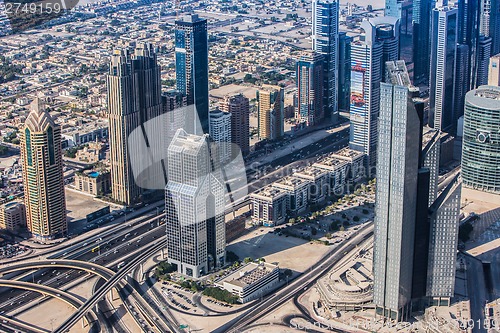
top-left (462, 86), bottom-right (500, 194)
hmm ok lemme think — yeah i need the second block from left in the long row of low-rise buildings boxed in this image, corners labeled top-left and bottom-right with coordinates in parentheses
top-left (272, 176), bottom-right (311, 214)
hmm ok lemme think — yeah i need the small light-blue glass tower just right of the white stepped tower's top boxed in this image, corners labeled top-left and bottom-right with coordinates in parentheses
top-left (209, 109), bottom-right (232, 164)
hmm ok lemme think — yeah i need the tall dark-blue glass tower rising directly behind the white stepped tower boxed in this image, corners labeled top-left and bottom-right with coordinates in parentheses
top-left (175, 14), bottom-right (209, 134)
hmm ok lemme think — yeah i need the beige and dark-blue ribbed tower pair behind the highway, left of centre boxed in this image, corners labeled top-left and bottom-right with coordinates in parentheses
top-left (107, 44), bottom-right (163, 205)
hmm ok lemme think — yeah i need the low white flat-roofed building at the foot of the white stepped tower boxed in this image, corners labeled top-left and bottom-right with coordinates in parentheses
top-left (216, 262), bottom-right (280, 303)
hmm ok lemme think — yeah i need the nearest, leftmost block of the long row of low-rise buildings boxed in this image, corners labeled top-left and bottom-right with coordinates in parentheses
top-left (251, 185), bottom-right (288, 227)
